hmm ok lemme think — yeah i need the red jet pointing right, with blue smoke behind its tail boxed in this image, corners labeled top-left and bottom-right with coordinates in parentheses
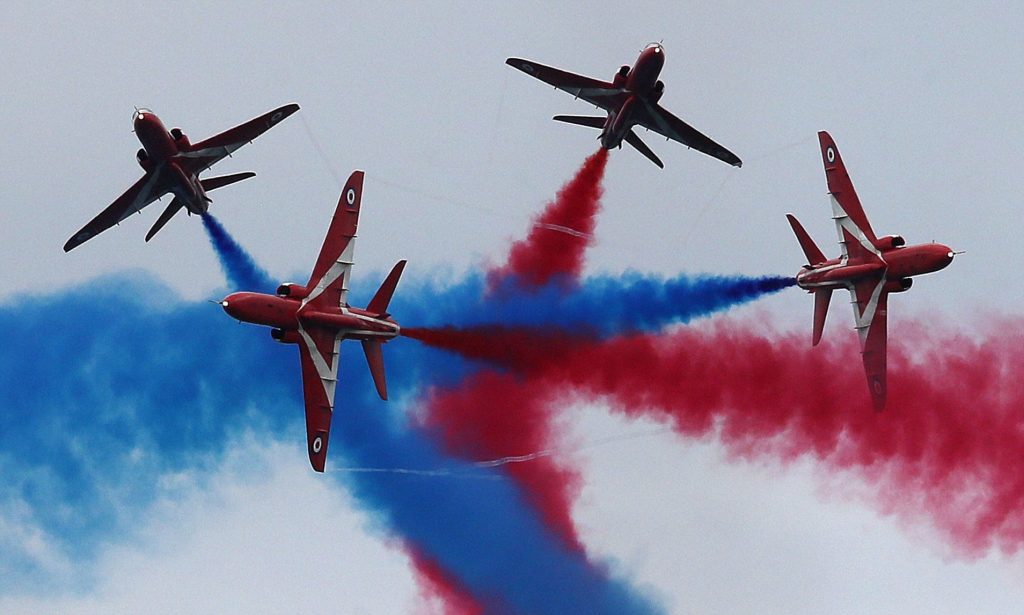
top-left (786, 131), bottom-right (956, 410)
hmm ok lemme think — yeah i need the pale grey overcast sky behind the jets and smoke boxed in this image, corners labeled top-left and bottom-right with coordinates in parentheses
top-left (0, 2), bottom-right (1024, 613)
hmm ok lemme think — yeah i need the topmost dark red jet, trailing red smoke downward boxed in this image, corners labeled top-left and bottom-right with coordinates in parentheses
top-left (505, 43), bottom-right (743, 169)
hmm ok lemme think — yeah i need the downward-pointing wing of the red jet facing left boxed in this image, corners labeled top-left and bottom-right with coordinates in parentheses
top-left (298, 328), bottom-right (341, 472)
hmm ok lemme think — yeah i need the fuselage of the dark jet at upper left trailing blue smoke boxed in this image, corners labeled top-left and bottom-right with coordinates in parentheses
top-left (133, 108), bottom-right (210, 215)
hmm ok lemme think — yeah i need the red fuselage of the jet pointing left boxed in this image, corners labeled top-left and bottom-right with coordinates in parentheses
top-left (220, 293), bottom-right (400, 342)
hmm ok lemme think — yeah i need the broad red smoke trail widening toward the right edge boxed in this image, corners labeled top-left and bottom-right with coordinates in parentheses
top-left (415, 320), bottom-right (1024, 557)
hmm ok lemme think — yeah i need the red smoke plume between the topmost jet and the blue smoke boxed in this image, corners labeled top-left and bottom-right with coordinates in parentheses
top-left (488, 148), bottom-right (608, 289)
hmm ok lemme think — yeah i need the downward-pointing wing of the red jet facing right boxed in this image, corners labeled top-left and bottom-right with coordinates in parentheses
top-left (850, 275), bottom-right (889, 411)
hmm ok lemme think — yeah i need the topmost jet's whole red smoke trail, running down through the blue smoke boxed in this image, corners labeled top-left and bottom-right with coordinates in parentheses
top-left (403, 148), bottom-right (608, 615)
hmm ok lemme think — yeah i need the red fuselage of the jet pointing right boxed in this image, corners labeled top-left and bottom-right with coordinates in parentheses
top-left (797, 244), bottom-right (954, 292)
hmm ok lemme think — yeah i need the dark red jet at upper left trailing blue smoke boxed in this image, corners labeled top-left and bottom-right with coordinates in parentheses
top-left (65, 104), bottom-right (299, 252)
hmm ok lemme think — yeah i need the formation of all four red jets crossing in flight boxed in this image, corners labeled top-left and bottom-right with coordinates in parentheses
top-left (63, 43), bottom-right (956, 472)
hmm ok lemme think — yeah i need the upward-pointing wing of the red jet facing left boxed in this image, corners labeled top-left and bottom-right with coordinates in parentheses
top-left (303, 171), bottom-right (364, 308)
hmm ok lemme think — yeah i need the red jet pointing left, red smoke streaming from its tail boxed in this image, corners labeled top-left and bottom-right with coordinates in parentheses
top-left (220, 171), bottom-right (406, 472)
